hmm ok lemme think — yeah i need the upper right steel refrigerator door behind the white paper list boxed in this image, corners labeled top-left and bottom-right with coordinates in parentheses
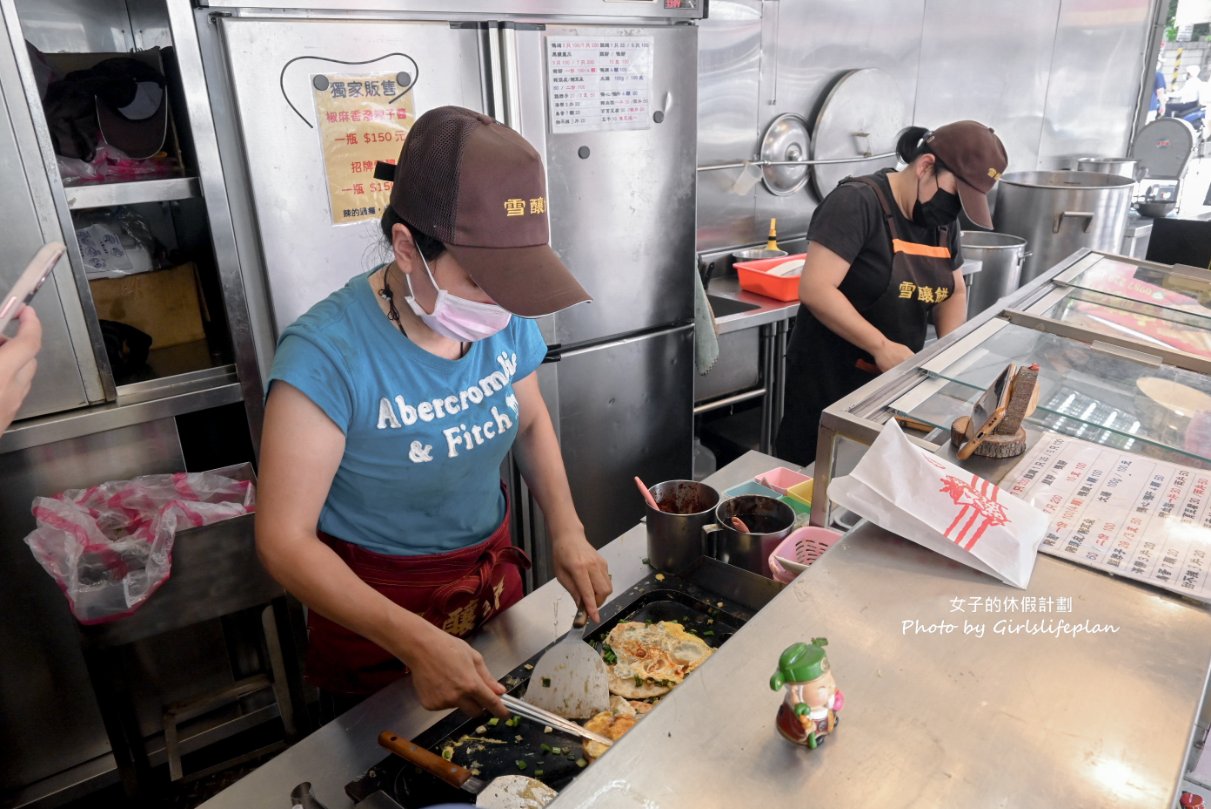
top-left (517, 25), bottom-right (698, 346)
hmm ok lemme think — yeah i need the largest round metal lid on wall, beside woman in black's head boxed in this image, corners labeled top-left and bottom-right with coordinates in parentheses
top-left (811, 68), bottom-right (908, 200)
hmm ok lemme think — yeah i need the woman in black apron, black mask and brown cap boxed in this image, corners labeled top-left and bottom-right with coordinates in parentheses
top-left (776, 121), bottom-right (1009, 464)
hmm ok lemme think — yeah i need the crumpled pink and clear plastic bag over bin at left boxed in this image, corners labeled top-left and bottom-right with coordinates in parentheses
top-left (25, 464), bottom-right (256, 624)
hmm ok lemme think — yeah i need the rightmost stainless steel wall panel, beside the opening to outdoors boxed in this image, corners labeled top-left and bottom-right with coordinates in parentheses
top-left (1039, 0), bottom-right (1152, 167)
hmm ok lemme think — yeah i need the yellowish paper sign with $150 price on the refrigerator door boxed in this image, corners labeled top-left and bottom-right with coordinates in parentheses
top-left (311, 73), bottom-right (415, 225)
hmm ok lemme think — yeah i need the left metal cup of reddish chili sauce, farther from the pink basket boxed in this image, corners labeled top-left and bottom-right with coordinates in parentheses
top-left (643, 481), bottom-right (719, 573)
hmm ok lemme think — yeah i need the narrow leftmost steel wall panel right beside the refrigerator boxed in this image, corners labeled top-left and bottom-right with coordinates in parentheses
top-left (698, 0), bottom-right (760, 249)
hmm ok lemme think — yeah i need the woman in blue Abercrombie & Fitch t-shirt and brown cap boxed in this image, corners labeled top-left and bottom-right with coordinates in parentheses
top-left (257, 107), bottom-right (612, 716)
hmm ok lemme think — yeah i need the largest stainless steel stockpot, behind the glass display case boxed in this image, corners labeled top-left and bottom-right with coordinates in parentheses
top-left (992, 171), bottom-right (1135, 283)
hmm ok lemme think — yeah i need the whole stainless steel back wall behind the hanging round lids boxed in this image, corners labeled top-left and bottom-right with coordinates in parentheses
top-left (695, 0), bottom-right (1157, 252)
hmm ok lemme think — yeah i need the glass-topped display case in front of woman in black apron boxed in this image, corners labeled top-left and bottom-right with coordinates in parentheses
top-left (813, 249), bottom-right (1211, 524)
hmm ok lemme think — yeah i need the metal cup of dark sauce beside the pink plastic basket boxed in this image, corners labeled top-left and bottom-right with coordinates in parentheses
top-left (702, 494), bottom-right (794, 578)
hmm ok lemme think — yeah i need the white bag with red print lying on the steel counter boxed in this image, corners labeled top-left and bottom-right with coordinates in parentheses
top-left (828, 419), bottom-right (1048, 587)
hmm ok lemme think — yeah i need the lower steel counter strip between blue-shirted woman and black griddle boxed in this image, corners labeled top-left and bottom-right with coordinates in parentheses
top-left (202, 452), bottom-right (782, 809)
